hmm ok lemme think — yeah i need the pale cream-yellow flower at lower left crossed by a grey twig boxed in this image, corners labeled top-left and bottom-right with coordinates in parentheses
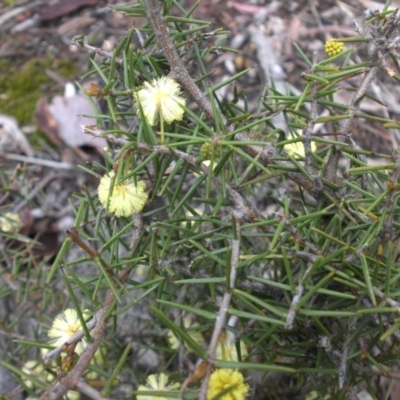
top-left (48, 308), bottom-right (86, 354)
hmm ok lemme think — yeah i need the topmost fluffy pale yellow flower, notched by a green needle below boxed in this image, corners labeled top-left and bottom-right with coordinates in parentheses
top-left (134, 76), bottom-right (185, 126)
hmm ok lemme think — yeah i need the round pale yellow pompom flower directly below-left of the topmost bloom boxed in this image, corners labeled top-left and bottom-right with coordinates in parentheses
top-left (98, 171), bottom-right (148, 217)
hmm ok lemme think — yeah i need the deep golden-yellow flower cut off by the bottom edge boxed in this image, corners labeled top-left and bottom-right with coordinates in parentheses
top-left (207, 368), bottom-right (249, 400)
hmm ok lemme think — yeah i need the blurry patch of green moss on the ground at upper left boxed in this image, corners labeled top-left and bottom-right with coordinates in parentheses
top-left (0, 58), bottom-right (79, 125)
